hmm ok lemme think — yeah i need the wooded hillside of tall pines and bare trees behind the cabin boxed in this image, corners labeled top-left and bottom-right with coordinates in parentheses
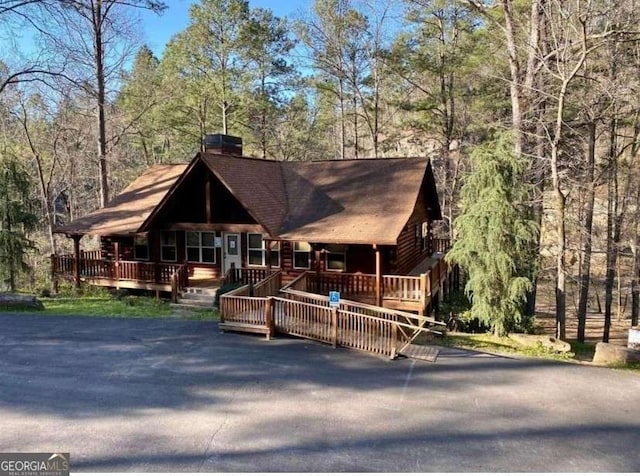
top-left (0, 0), bottom-right (640, 340)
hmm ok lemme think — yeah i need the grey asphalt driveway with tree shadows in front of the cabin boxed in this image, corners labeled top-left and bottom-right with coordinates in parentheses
top-left (0, 314), bottom-right (640, 472)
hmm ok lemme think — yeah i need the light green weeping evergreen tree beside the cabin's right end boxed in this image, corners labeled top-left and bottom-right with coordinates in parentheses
top-left (447, 136), bottom-right (536, 335)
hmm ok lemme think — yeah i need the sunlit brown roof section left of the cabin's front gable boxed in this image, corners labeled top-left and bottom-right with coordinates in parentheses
top-left (56, 164), bottom-right (188, 235)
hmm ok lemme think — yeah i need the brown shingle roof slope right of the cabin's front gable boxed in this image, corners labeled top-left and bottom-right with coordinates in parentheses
top-left (280, 158), bottom-right (428, 245)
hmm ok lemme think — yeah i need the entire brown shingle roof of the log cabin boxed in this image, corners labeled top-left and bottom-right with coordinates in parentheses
top-left (58, 153), bottom-right (439, 245)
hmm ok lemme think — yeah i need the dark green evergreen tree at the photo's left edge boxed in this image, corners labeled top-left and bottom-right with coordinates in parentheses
top-left (0, 153), bottom-right (38, 291)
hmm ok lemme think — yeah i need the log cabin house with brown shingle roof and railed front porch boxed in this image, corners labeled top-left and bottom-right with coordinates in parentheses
top-left (52, 134), bottom-right (448, 308)
